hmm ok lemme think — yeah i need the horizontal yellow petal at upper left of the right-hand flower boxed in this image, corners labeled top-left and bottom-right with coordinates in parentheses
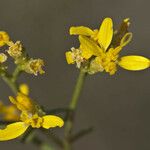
top-left (70, 26), bottom-right (94, 36)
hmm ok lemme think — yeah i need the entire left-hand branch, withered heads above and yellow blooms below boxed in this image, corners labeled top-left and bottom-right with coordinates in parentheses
top-left (0, 31), bottom-right (64, 141)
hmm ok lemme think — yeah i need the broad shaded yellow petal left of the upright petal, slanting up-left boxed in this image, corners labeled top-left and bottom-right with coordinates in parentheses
top-left (79, 35), bottom-right (103, 59)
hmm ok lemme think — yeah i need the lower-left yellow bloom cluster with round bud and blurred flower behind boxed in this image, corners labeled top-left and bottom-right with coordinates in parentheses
top-left (0, 84), bottom-right (64, 141)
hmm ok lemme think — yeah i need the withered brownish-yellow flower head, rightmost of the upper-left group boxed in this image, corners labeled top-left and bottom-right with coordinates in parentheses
top-left (24, 59), bottom-right (45, 76)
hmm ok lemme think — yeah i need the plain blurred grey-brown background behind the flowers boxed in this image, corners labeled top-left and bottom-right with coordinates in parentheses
top-left (0, 0), bottom-right (150, 150)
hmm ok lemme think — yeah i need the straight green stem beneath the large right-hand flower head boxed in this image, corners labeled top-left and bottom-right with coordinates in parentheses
top-left (64, 69), bottom-right (86, 150)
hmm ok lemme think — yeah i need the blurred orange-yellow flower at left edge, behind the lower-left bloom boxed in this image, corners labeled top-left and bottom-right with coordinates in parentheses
top-left (0, 101), bottom-right (20, 121)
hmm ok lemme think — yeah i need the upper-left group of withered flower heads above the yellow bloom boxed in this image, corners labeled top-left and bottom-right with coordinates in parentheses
top-left (0, 31), bottom-right (44, 75)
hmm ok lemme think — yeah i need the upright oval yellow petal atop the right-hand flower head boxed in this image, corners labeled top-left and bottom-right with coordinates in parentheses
top-left (98, 18), bottom-right (113, 51)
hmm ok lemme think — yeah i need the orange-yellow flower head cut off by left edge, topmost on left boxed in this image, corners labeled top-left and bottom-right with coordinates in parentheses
top-left (0, 31), bottom-right (9, 47)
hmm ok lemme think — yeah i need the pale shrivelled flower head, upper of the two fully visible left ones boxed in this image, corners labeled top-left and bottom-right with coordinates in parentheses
top-left (7, 41), bottom-right (23, 59)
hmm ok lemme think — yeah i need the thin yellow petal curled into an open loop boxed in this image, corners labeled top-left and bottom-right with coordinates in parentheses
top-left (120, 32), bottom-right (132, 47)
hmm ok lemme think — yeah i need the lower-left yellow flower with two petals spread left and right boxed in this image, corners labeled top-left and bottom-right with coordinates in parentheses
top-left (0, 93), bottom-right (64, 141)
